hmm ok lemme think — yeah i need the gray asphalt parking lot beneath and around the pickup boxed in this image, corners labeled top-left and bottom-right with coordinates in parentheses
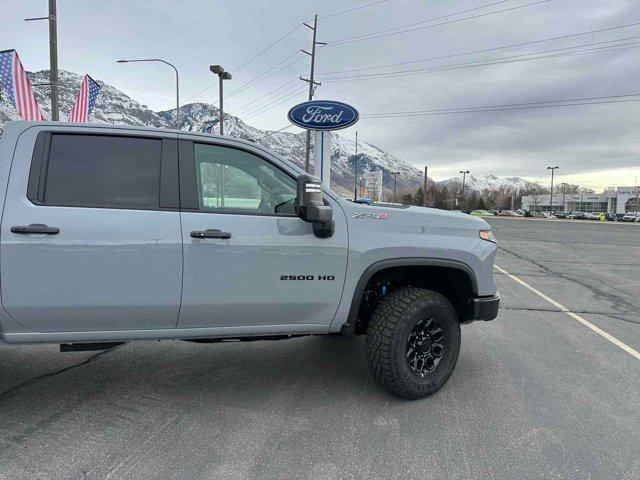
top-left (0, 218), bottom-right (640, 480)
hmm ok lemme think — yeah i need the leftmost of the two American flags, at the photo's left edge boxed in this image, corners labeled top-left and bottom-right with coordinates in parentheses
top-left (0, 50), bottom-right (43, 120)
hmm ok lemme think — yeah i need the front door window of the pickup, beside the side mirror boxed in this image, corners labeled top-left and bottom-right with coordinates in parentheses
top-left (194, 144), bottom-right (296, 215)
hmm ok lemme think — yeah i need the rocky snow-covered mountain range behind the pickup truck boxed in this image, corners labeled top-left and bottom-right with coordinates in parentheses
top-left (0, 70), bottom-right (422, 195)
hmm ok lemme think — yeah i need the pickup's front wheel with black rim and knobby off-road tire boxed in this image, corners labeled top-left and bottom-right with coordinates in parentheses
top-left (366, 287), bottom-right (460, 400)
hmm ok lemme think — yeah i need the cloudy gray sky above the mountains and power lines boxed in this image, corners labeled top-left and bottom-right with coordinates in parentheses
top-left (0, 0), bottom-right (640, 188)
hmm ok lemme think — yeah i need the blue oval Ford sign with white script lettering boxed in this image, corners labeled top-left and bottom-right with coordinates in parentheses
top-left (287, 100), bottom-right (359, 130)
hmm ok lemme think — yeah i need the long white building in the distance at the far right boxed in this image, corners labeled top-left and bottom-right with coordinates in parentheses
top-left (522, 187), bottom-right (640, 213)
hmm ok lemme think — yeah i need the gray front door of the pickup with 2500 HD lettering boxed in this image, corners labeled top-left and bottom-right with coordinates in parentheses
top-left (178, 141), bottom-right (347, 333)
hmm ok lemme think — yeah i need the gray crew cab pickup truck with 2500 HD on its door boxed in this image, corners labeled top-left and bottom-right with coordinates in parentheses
top-left (0, 122), bottom-right (499, 399)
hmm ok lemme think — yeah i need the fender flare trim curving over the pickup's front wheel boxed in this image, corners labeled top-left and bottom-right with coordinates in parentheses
top-left (342, 257), bottom-right (478, 336)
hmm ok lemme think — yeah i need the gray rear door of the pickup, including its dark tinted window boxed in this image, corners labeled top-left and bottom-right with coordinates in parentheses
top-left (0, 126), bottom-right (182, 332)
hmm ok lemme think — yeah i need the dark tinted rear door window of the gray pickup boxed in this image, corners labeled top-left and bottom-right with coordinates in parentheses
top-left (44, 135), bottom-right (162, 208)
